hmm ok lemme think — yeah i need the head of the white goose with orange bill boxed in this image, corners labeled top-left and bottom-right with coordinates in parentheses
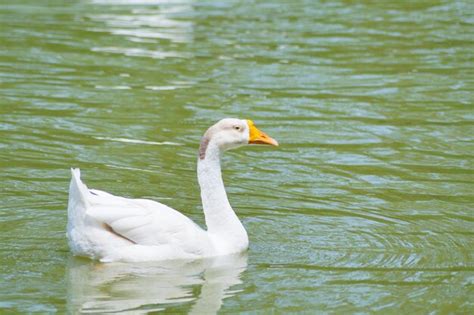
top-left (199, 118), bottom-right (278, 160)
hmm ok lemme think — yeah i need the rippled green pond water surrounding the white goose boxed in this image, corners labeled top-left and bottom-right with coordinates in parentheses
top-left (0, 0), bottom-right (474, 314)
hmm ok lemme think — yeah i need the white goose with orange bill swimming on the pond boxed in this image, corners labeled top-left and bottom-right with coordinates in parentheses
top-left (67, 118), bottom-right (278, 262)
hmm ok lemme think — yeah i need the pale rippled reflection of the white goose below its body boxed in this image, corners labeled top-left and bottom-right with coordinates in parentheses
top-left (67, 253), bottom-right (247, 314)
